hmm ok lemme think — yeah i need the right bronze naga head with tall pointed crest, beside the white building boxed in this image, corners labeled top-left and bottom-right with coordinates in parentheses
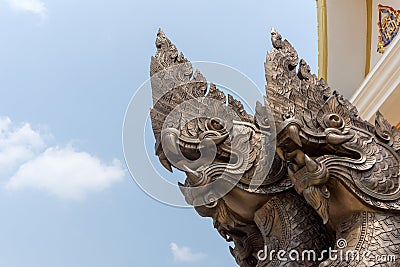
top-left (265, 29), bottom-right (400, 229)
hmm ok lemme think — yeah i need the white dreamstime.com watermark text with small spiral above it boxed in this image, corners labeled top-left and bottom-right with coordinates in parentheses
top-left (257, 238), bottom-right (396, 266)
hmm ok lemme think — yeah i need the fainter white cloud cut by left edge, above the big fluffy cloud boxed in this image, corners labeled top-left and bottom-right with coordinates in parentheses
top-left (0, 117), bottom-right (45, 174)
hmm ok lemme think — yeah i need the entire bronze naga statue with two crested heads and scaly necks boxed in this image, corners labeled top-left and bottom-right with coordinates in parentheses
top-left (150, 30), bottom-right (400, 267)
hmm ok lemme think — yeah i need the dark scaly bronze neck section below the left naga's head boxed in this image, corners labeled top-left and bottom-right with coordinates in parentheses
top-left (254, 193), bottom-right (331, 267)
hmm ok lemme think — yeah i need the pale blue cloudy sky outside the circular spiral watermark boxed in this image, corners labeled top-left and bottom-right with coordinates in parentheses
top-left (0, 0), bottom-right (317, 267)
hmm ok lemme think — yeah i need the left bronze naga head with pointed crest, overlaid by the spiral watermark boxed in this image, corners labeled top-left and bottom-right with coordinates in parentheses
top-left (150, 30), bottom-right (291, 206)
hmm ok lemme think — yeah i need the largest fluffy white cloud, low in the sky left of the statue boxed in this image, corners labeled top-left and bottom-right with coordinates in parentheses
top-left (6, 147), bottom-right (124, 199)
